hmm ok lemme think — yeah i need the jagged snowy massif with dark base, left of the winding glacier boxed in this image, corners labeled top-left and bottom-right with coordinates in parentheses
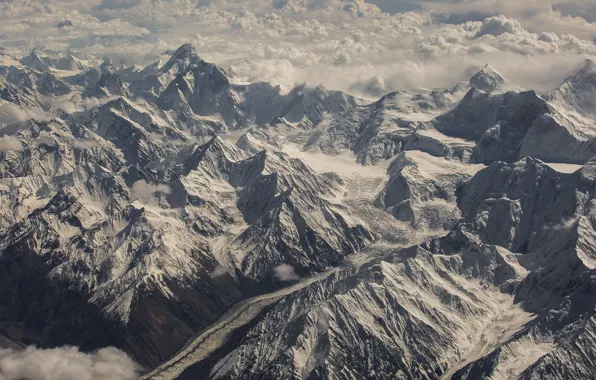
top-left (0, 53), bottom-right (374, 366)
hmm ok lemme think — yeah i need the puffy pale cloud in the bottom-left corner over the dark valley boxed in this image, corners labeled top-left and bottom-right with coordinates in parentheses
top-left (0, 347), bottom-right (140, 380)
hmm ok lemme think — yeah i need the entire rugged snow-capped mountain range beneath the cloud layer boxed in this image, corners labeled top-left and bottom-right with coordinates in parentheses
top-left (0, 44), bottom-right (596, 380)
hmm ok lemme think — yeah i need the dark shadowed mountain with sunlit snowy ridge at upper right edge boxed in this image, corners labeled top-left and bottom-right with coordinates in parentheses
top-left (432, 89), bottom-right (596, 164)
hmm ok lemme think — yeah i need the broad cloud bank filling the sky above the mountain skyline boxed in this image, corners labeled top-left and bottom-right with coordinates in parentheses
top-left (0, 0), bottom-right (596, 98)
